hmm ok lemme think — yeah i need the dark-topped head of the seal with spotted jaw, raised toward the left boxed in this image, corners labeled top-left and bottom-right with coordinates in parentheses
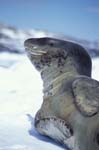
top-left (24, 37), bottom-right (92, 76)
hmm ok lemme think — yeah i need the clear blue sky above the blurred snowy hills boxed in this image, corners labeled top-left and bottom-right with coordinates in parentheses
top-left (0, 0), bottom-right (99, 40)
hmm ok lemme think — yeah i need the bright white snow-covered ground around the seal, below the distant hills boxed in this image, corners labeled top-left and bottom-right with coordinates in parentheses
top-left (0, 53), bottom-right (99, 150)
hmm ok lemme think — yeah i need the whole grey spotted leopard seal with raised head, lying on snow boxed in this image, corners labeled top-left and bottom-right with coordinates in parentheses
top-left (24, 37), bottom-right (99, 150)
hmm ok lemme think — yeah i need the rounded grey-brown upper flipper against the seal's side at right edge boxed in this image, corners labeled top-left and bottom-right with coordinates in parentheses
top-left (72, 77), bottom-right (99, 117)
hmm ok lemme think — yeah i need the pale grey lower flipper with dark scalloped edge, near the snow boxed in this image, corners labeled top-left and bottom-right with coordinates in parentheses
top-left (35, 117), bottom-right (74, 150)
